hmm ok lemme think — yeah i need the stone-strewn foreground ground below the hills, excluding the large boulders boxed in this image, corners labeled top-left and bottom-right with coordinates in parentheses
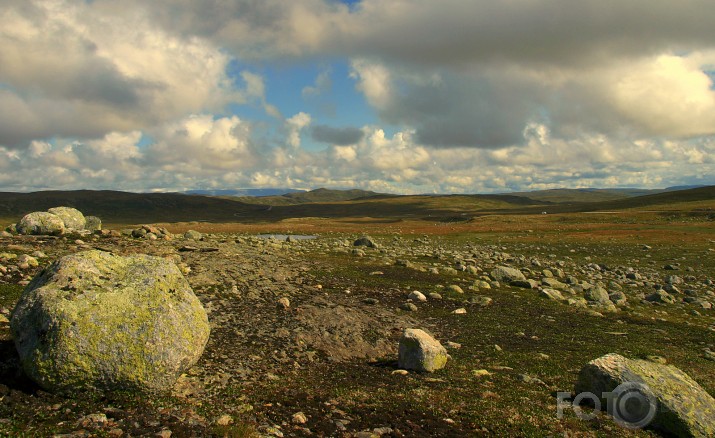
top-left (0, 227), bottom-right (715, 436)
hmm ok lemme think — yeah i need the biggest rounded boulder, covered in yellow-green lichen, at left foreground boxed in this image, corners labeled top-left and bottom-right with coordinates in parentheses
top-left (11, 251), bottom-right (209, 392)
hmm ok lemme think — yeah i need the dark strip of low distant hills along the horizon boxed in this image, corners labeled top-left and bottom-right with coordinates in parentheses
top-left (0, 186), bottom-right (715, 224)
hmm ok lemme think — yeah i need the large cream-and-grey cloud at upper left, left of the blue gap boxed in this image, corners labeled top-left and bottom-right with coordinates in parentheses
top-left (0, 0), bottom-right (243, 147)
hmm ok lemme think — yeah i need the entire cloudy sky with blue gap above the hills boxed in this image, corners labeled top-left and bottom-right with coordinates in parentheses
top-left (0, 0), bottom-right (715, 194)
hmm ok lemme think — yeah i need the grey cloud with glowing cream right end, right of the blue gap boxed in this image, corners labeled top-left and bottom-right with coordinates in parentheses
top-left (352, 52), bottom-right (715, 148)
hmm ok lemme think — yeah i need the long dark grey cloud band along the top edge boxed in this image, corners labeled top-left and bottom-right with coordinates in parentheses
top-left (133, 0), bottom-right (715, 66)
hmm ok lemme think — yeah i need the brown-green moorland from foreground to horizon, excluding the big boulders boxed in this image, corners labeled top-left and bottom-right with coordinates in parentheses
top-left (0, 187), bottom-right (715, 437)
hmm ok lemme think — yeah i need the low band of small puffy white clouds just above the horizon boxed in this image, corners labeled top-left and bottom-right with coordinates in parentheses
top-left (0, 122), bottom-right (715, 193)
